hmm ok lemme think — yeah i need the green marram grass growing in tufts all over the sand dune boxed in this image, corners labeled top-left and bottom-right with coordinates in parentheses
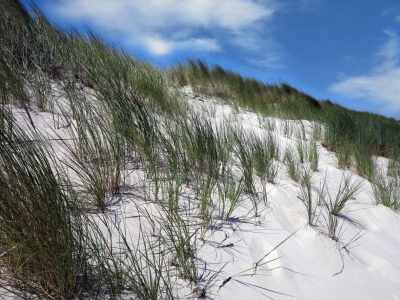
top-left (0, 0), bottom-right (400, 299)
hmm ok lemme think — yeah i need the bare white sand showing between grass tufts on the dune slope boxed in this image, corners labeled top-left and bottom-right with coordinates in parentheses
top-left (3, 85), bottom-right (400, 300)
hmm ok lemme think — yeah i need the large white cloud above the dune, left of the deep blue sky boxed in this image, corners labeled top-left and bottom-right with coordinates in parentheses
top-left (51, 0), bottom-right (275, 55)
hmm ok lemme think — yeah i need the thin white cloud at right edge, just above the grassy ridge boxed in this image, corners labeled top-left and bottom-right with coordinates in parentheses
top-left (329, 30), bottom-right (400, 113)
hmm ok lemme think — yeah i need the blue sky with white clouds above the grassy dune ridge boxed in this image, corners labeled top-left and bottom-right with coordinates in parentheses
top-left (22, 0), bottom-right (400, 119)
